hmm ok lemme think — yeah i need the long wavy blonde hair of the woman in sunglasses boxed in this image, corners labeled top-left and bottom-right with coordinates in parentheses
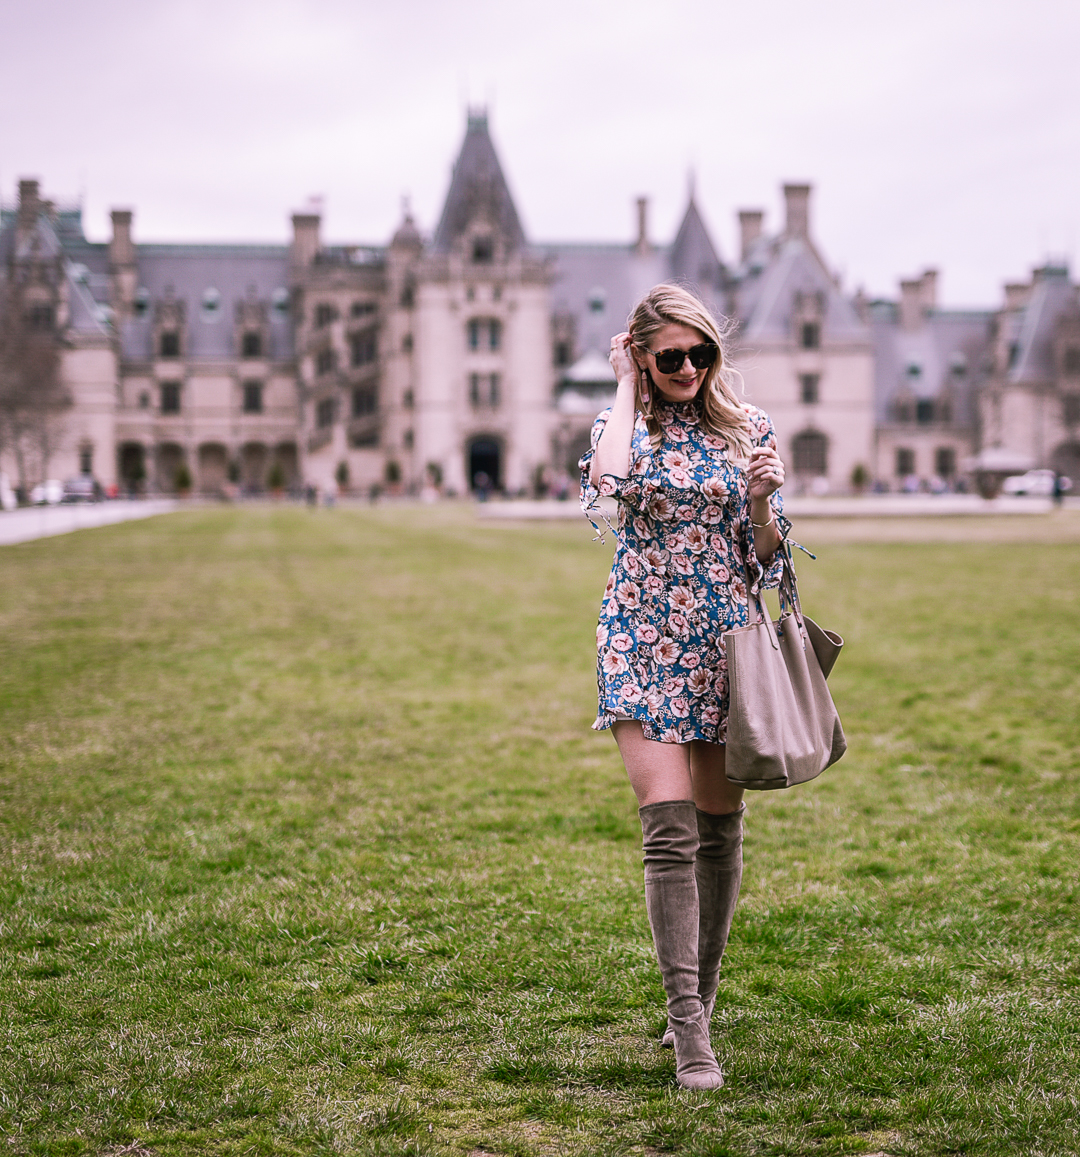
top-left (626, 285), bottom-right (750, 457)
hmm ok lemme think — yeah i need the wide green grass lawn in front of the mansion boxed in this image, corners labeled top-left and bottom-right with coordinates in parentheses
top-left (0, 507), bottom-right (1080, 1157)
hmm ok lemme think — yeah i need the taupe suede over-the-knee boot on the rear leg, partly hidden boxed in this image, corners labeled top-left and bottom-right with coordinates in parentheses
top-left (663, 804), bottom-right (747, 1048)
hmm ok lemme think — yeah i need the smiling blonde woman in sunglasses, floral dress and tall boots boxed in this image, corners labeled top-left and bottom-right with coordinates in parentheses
top-left (581, 285), bottom-right (789, 1089)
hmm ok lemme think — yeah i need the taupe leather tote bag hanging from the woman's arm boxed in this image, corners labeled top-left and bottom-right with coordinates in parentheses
top-left (723, 543), bottom-right (847, 791)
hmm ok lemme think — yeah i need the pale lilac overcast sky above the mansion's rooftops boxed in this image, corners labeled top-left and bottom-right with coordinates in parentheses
top-left (0, 0), bottom-right (1080, 304)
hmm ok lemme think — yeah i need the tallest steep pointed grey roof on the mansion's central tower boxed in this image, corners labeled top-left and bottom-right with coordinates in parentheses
top-left (434, 110), bottom-right (526, 253)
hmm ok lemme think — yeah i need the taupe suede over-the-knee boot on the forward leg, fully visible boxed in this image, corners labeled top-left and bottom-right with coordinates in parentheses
top-left (638, 799), bottom-right (723, 1089)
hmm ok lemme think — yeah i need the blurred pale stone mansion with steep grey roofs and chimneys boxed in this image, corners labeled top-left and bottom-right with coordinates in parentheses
top-left (0, 112), bottom-right (1080, 494)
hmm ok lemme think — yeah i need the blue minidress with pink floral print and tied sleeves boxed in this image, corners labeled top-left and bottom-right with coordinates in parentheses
top-left (579, 401), bottom-right (791, 743)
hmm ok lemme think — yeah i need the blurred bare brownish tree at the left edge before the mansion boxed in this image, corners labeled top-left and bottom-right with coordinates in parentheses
top-left (0, 287), bottom-right (72, 493)
